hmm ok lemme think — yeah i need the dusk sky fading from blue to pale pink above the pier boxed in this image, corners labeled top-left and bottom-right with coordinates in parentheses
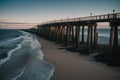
top-left (0, 0), bottom-right (120, 28)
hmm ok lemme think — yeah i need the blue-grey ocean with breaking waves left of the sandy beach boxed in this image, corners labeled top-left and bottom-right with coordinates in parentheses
top-left (0, 29), bottom-right (54, 80)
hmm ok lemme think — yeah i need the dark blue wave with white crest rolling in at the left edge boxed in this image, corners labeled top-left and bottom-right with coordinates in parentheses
top-left (0, 30), bottom-right (23, 66)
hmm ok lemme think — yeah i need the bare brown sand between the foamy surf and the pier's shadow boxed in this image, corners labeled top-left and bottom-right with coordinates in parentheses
top-left (38, 38), bottom-right (120, 80)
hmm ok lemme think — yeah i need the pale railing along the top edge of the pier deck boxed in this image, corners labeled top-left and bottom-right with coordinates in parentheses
top-left (43, 13), bottom-right (120, 24)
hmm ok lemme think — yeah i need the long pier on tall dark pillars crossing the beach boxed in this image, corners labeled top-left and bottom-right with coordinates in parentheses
top-left (37, 13), bottom-right (120, 55)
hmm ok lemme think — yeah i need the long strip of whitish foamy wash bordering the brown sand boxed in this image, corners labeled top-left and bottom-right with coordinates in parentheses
top-left (17, 32), bottom-right (54, 80)
